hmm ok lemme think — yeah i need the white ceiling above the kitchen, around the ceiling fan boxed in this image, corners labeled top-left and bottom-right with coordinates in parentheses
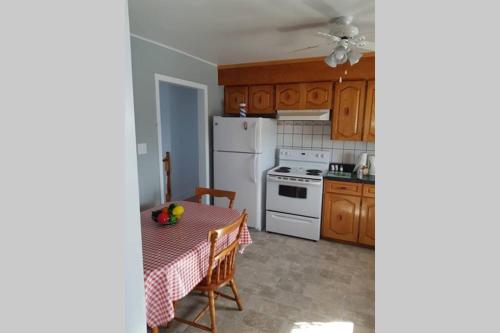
top-left (129, 0), bottom-right (375, 65)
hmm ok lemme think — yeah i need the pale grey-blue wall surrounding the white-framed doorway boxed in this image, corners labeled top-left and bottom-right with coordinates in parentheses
top-left (131, 37), bottom-right (224, 209)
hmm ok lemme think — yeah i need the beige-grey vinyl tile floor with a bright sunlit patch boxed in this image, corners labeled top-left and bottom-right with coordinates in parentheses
top-left (150, 231), bottom-right (375, 333)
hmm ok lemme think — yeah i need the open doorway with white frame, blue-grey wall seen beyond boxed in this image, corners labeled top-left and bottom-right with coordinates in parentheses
top-left (155, 74), bottom-right (210, 204)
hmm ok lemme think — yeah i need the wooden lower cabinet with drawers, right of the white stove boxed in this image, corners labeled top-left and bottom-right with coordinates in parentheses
top-left (321, 180), bottom-right (375, 246)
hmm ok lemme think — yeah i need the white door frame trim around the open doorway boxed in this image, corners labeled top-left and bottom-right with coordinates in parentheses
top-left (154, 73), bottom-right (210, 204)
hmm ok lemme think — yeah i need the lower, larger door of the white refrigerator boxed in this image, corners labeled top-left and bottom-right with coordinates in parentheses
top-left (214, 151), bottom-right (263, 230)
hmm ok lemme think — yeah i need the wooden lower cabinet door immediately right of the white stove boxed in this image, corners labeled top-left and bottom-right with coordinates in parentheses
top-left (321, 193), bottom-right (361, 242)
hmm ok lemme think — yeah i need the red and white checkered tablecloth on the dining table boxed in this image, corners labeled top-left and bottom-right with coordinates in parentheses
top-left (141, 201), bottom-right (252, 327)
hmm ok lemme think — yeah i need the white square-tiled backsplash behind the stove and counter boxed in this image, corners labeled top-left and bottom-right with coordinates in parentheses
top-left (277, 120), bottom-right (375, 163)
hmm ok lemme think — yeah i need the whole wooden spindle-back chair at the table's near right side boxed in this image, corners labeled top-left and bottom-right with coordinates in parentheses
top-left (174, 210), bottom-right (248, 333)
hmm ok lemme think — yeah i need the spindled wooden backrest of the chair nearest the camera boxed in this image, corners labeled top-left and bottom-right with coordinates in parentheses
top-left (207, 209), bottom-right (248, 285)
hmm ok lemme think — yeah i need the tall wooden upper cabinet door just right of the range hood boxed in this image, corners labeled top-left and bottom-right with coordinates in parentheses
top-left (332, 81), bottom-right (366, 141)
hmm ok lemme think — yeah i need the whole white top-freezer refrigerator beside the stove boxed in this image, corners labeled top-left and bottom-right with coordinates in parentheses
top-left (213, 116), bottom-right (276, 230)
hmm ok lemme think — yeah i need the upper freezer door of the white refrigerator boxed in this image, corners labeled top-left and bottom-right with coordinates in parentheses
top-left (214, 116), bottom-right (262, 154)
